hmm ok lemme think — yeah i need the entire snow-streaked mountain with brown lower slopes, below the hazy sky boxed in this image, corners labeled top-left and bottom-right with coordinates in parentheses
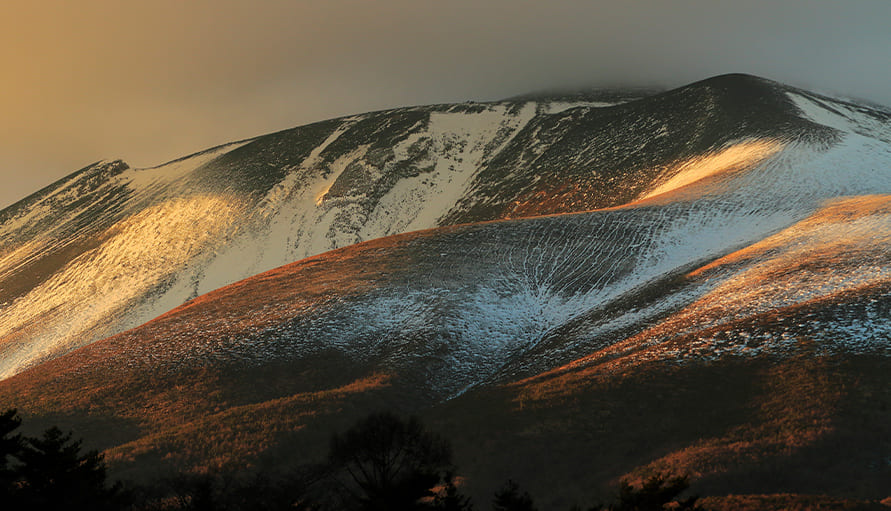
top-left (0, 75), bottom-right (891, 507)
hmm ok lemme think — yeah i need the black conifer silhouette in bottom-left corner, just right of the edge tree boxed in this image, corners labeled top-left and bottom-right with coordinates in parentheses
top-left (17, 427), bottom-right (122, 510)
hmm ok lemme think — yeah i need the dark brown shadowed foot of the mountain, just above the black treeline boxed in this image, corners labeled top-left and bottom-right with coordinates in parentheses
top-left (0, 322), bottom-right (891, 509)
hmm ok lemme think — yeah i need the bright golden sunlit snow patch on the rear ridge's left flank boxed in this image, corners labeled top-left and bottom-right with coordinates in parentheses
top-left (0, 196), bottom-right (234, 377)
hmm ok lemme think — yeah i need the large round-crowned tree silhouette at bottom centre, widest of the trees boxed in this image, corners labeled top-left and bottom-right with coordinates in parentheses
top-left (328, 412), bottom-right (451, 511)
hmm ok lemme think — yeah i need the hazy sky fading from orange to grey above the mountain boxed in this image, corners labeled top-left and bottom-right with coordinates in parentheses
top-left (0, 0), bottom-right (891, 208)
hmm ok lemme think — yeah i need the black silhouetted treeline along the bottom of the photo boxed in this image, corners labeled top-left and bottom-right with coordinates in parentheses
top-left (0, 410), bottom-right (698, 511)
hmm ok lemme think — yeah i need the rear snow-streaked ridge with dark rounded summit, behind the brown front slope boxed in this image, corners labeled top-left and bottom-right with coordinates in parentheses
top-left (0, 75), bottom-right (838, 376)
